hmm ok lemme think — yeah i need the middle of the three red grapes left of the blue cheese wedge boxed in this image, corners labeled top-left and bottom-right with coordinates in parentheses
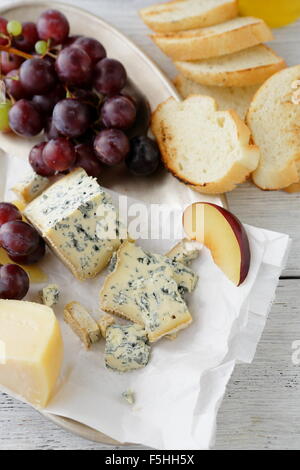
top-left (0, 220), bottom-right (40, 255)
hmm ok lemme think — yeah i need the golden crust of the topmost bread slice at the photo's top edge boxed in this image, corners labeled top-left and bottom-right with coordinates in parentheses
top-left (139, 0), bottom-right (238, 33)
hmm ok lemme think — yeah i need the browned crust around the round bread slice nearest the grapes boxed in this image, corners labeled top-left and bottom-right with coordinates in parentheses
top-left (152, 95), bottom-right (259, 194)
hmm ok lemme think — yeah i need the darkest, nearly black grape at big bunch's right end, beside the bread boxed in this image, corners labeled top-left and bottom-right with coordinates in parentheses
top-left (125, 136), bottom-right (161, 176)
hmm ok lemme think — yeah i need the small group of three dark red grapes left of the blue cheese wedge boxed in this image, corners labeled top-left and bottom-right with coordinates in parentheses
top-left (0, 202), bottom-right (46, 300)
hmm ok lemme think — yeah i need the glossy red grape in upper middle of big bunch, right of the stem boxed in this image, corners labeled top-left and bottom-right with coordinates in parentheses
top-left (55, 46), bottom-right (92, 87)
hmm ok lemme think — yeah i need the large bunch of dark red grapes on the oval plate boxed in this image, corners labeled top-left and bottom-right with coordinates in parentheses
top-left (0, 10), bottom-right (160, 177)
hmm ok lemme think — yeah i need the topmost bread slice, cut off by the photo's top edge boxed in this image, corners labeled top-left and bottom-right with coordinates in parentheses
top-left (140, 0), bottom-right (238, 33)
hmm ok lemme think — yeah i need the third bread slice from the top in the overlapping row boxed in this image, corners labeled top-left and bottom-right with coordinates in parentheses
top-left (175, 44), bottom-right (286, 87)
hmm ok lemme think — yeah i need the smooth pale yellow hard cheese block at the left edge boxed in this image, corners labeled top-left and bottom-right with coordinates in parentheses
top-left (0, 300), bottom-right (63, 408)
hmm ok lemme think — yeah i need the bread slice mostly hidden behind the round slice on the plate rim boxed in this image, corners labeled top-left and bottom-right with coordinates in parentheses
top-left (174, 75), bottom-right (259, 120)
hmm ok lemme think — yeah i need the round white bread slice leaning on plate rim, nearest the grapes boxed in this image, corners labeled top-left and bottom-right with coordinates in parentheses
top-left (152, 95), bottom-right (259, 194)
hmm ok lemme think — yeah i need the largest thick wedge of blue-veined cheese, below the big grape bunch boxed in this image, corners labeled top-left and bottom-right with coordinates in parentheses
top-left (24, 169), bottom-right (120, 280)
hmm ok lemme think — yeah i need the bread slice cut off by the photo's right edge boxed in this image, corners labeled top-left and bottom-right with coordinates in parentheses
top-left (247, 65), bottom-right (300, 189)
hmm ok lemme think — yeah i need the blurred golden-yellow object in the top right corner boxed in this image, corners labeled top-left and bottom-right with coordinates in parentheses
top-left (239, 0), bottom-right (300, 28)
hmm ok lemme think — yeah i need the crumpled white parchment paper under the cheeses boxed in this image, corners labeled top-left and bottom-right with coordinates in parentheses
top-left (0, 155), bottom-right (290, 449)
